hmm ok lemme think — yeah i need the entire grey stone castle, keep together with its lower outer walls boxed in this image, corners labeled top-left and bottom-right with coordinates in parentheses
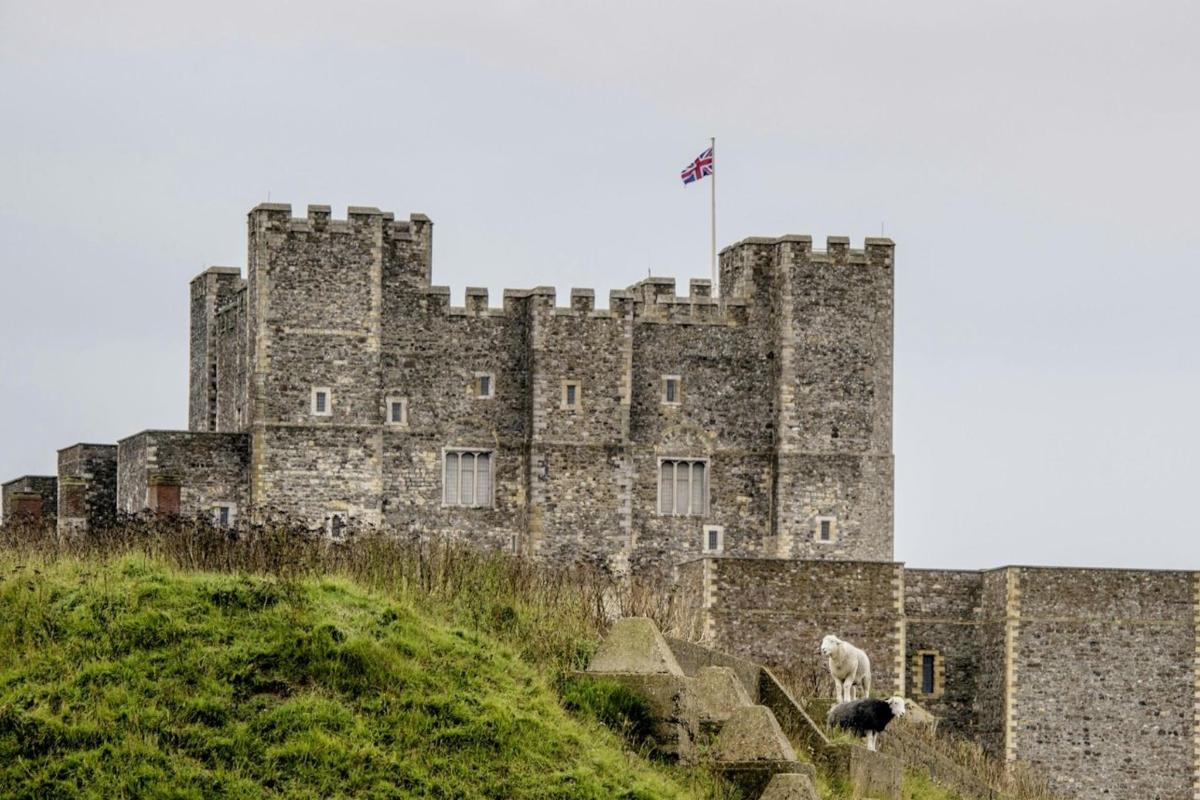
top-left (2, 204), bottom-right (1200, 800)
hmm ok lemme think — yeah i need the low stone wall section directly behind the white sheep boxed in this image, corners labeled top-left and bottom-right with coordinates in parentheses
top-left (679, 558), bottom-right (905, 697)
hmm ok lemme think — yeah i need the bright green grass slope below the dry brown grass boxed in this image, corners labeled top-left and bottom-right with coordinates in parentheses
top-left (0, 555), bottom-right (692, 800)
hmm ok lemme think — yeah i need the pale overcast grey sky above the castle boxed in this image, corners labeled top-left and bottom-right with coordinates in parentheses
top-left (0, 0), bottom-right (1200, 569)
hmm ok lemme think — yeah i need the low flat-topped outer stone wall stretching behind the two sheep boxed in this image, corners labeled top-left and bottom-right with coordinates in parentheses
top-left (678, 558), bottom-right (1200, 800)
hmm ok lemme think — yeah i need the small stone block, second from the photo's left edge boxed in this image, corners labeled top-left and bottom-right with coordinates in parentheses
top-left (58, 444), bottom-right (116, 535)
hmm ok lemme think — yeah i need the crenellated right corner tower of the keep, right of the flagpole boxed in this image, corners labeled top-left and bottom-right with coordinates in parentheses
top-left (721, 236), bottom-right (894, 561)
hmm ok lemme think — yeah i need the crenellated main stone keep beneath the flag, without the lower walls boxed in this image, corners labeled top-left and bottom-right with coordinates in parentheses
top-left (169, 204), bottom-right (893, 575)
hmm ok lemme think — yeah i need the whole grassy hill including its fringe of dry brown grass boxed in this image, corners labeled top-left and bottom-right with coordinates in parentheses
top-left (0, 519), bottom-right (1043, 800)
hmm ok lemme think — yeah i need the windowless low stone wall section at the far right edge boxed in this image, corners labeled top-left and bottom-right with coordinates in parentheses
top-left (1010, 567), bottom-right (1200, 800)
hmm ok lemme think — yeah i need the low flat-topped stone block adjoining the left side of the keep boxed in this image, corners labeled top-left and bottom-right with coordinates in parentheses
top-left (116, 431), bottom-right (250, 519)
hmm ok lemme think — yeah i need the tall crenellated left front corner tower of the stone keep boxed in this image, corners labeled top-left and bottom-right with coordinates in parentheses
top-left (246, 204), bottom-right (431, 530)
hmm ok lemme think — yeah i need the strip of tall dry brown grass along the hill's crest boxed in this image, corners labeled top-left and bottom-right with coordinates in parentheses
top-left (0, 516), bottom-right (670, 672)
